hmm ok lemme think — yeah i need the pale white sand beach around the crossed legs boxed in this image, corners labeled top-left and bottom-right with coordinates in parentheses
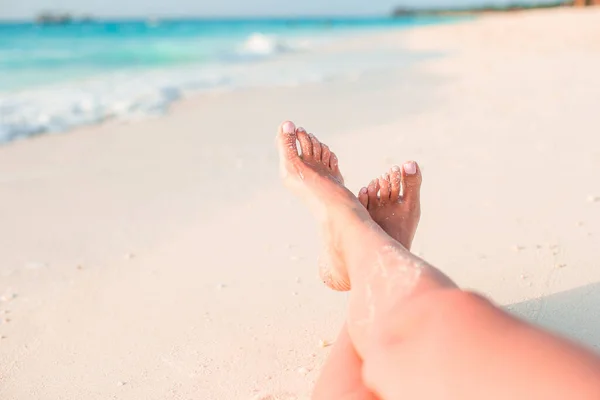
top-left (0, 9), bottom-right (600, 400)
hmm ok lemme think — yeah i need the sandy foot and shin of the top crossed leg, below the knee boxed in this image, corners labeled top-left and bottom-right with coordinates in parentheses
top-left (277, 121), bottom-right (455, 359)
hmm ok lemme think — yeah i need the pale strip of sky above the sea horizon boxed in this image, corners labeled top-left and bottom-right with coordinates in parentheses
top-left (0, 0), bottom-right (564, 19)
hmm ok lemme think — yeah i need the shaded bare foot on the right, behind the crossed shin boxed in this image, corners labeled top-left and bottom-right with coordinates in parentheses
top-left (358, 161), bottom-right (422, 250)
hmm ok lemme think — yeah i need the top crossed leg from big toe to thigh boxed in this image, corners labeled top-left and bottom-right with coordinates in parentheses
top-left (279, 122), bottom-right (600, 399)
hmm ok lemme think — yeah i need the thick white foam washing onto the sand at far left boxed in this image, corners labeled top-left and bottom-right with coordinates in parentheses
top-left (0, 74), bottom-right (227, 143)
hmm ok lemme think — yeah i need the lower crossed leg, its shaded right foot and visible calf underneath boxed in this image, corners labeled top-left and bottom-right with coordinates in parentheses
top-left (313, 162), bottom-right (421, 400)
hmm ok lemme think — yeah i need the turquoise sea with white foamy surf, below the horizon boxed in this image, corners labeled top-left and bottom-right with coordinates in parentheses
top-left (0, 17), bottom-right (460, 142)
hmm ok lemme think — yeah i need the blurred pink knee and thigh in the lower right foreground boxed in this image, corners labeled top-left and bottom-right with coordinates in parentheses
top-left (364, 290), bottom-right (600, 400)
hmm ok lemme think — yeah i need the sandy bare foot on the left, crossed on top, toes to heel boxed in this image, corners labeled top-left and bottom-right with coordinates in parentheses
top-left (277, 121), bottom-right (371, 291)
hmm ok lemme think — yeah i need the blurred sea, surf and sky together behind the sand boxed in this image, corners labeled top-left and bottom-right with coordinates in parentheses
top-left (0, 0), bottom-right (572, 142)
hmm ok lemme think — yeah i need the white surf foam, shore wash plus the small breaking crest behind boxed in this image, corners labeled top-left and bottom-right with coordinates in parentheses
top-left (0, 33), bottom-right (309, 143)
